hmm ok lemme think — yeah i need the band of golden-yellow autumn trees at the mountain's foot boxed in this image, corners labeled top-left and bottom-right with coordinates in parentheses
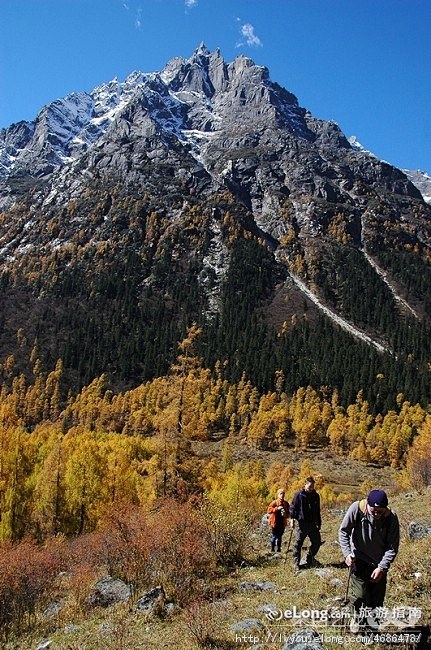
top-left (0, 325), bottom-right (431, 540)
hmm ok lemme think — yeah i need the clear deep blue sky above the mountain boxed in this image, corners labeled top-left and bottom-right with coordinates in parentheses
top-left (0, 0), bottom-right (431, 173)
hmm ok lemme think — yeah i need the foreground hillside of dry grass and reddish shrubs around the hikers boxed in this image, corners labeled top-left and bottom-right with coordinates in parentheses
top-left (1, 484), bottom-right (431, 650)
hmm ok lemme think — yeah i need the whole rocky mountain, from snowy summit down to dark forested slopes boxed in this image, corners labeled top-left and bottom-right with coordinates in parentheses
top-left (0, 43), bottom-right (431, 404)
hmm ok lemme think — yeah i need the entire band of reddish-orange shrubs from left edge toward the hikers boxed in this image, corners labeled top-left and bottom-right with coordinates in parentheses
top-left (0, 498), bottom-right (250, 639)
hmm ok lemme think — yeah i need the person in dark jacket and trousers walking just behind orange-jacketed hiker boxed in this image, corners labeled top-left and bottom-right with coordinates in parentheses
top-left (290, 476), bottom-right (322, 570)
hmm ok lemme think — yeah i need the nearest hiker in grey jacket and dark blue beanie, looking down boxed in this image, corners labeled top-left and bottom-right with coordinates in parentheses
top-left (338, 490), bottom-right (400, 627)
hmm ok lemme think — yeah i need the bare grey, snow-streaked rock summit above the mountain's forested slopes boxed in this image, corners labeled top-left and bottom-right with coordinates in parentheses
top-left (0, 43), bottom-right (426, 215)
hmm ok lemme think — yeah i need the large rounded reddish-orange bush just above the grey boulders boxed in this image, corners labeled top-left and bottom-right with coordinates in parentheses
top-left (79, 498), bottom-right (215, 604)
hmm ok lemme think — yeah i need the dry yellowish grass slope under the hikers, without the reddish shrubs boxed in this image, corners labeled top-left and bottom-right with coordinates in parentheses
top-left (7, 492), bottom-right (431, 650)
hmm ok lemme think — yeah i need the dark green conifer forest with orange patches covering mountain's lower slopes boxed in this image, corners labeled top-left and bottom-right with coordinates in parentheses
top-left (0, 186), bottom-right (431, 415)
